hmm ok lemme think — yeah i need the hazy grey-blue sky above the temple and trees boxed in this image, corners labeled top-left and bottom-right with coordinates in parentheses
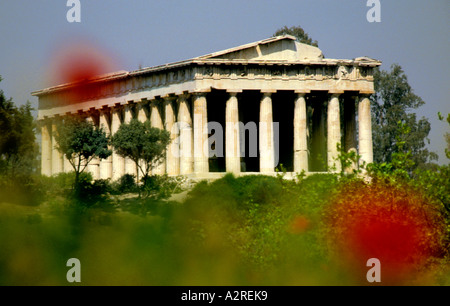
top-left (0, 0), bottom-right (450, 163)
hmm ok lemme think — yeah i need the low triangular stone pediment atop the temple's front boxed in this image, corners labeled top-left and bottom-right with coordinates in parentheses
top-left (197, 35), bottom-right (324, 62)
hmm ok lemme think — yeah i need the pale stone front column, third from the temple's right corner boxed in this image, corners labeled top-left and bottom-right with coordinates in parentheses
top-left (294, 93), bottom-right (308, 173)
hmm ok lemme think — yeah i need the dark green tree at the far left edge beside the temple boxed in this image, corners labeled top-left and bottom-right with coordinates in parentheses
top-left (0, 77), bottom-right (38, 178)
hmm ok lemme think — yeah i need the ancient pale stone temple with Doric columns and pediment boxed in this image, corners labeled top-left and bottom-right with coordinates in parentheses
top-left (33, 36), bottom-right (381, 180)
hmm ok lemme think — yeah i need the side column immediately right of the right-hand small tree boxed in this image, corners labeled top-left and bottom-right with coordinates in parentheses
top-left (164, 96), bottom-right (180, 175)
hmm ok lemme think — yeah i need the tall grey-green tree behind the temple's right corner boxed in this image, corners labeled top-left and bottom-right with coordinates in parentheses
top-left (371, 64), bottom-right (437, 168)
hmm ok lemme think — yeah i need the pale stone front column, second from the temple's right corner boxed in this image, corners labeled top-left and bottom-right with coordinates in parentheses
top-left (327, 94), bottom-right (341, 172)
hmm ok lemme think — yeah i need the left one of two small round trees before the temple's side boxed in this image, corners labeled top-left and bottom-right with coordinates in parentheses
top-left (55, 117), bottom-right (112, 189)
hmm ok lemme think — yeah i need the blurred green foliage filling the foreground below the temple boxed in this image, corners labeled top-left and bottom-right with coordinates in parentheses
top-left (0, 170), bottom-right (450, 286)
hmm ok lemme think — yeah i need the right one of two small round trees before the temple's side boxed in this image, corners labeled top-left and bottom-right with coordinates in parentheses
top-left (111, 119), bottom-right (170, 182)
